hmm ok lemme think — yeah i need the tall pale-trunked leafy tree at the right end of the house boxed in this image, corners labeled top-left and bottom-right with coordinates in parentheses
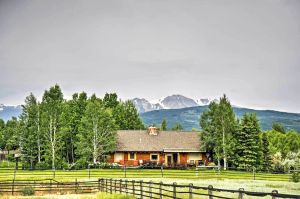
top-left (200, 95), bottom-right (237, 170)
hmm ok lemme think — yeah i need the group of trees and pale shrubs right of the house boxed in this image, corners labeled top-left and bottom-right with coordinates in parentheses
top-left (200, 95), bottom-right (300, 172)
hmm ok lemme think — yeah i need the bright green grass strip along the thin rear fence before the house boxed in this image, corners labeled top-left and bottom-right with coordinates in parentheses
top-left (0, 169), bottom-right (291, 181)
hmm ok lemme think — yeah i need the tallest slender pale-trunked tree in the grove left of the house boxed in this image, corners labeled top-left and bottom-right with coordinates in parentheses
top-left (42, 84), bottom-right (64, 170)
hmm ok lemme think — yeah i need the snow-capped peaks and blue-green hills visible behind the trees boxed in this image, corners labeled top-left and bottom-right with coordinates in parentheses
top-left (0, 95), bottom-right (300, 132)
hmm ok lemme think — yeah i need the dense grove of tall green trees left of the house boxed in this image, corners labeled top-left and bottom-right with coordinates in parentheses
top-left (0, 85), bottom-right (144, 170)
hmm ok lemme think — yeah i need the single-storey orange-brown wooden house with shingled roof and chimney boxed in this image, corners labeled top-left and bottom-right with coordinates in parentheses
top-left (108, 127), bottom-right (209, 166)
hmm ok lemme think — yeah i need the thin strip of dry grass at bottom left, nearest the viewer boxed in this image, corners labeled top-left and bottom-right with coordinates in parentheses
top-left (0, 192), bottom-right (135, 199)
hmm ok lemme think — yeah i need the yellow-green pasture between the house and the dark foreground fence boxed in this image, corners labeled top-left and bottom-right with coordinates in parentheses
top-left (0, 169), bottom-right (300, 195)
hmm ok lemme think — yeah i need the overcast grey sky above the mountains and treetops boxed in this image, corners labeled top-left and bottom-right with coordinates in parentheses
top-left (0, 0), bottom-right (300, 113)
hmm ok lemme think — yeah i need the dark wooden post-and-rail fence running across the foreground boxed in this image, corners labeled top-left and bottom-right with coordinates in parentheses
top-left (0, 178), bottom-right (300, 199)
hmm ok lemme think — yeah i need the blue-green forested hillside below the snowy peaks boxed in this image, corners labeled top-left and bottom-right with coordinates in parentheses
top-left (140, 106), bottom-right (300, 132)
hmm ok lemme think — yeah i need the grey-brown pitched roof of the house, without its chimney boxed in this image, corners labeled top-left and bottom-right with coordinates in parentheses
top-left (116, 130), bottom-right (200, 152)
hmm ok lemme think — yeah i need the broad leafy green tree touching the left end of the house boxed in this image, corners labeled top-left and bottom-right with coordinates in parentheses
top-left (77, 95), bottom-right (117, 164)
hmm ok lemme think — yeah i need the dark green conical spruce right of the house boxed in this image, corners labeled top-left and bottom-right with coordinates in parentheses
top-left (237, 113), bottom-right (261, 170)
